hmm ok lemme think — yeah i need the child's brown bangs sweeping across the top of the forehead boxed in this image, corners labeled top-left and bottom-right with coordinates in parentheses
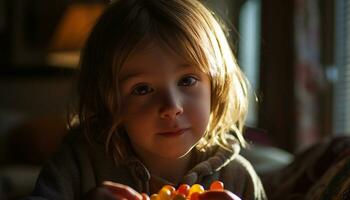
top-left (114, 1), bottom-right (210, 74)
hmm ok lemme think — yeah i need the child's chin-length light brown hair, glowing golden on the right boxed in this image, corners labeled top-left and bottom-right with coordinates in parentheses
top-left (73, 0), bottom-right (248, 160)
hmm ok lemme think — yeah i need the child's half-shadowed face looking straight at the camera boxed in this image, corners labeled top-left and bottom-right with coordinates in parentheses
top-left (119, 45), bottom-right (210, 159)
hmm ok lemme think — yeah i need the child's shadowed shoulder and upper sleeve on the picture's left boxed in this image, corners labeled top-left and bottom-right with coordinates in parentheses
top-left (33, 126), bottom-right (105, 199)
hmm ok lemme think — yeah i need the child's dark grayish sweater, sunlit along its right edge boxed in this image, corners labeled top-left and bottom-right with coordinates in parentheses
top-left (25, 133), bottom-right (266, 200)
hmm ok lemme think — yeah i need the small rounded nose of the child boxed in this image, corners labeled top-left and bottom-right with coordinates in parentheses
top-left (159, 91), bottom-right (183, 119)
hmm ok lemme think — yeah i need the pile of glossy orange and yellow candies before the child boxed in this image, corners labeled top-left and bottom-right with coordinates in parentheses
top-left (150, 181), bottom-right (224, 200)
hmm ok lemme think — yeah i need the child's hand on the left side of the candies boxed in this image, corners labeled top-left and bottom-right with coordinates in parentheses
top-left (86, 181), bottom-right (149, 200)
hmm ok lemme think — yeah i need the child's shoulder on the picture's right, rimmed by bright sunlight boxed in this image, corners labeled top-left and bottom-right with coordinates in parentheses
top-left (220, 155), bottom-right (266, 200)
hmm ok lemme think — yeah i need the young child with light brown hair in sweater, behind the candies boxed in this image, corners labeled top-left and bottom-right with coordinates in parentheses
top-left (25, 0), bottom-right (266, 200)
